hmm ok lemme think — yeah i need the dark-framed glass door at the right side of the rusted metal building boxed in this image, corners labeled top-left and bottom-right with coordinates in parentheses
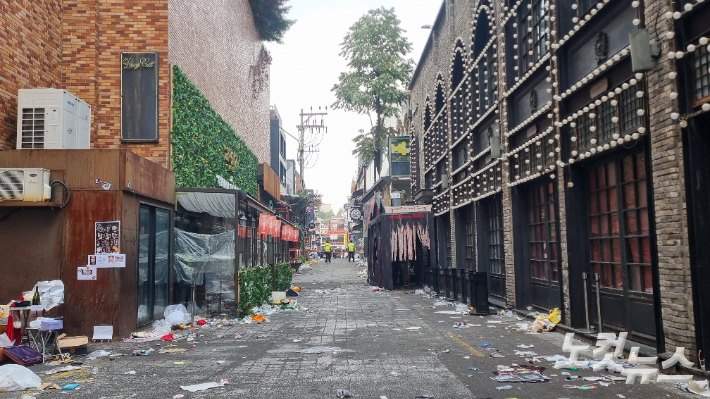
top-left (138, 204), bottom-right (170, 325)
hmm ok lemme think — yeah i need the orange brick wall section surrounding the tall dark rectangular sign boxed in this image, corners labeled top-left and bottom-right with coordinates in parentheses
top-left (62, 0), bottom-right (171, 168)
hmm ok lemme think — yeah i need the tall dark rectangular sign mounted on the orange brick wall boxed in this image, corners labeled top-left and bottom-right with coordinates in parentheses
top-left (121, 52), bottom-right (159, 141)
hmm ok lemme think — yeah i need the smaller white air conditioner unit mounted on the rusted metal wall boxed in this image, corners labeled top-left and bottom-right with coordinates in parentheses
top-left (0, 168), bottom-right (52, 202)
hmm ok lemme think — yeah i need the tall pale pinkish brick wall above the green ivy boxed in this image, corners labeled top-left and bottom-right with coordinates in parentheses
top-left (169, 0), bottom-right (278, 164)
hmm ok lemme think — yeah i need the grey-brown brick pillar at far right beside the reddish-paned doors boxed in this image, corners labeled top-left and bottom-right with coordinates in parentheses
top-left (645, 1), bottom-right (697, 359)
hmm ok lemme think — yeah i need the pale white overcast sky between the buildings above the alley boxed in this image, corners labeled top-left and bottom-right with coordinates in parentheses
top-left (267, 0), bottom-right (441, 212)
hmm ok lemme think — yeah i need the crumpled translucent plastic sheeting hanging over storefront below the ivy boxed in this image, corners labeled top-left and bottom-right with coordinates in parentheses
top-left (175, 229), bottom-right (235, 294)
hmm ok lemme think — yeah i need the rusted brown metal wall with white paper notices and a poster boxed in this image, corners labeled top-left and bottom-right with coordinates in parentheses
top-left (0, 150), bottom-right (175, 337)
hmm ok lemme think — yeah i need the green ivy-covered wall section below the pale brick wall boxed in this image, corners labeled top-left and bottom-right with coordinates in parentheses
top-left (172, 65), bottom-right (258, 197)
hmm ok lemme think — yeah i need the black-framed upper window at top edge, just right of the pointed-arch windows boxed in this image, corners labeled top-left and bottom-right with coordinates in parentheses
top-left (517, 0), bottom-right (550, 76)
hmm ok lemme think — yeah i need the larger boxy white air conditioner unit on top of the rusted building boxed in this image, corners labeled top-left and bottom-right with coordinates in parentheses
top-left (17, 89), bottom-right (91, 150)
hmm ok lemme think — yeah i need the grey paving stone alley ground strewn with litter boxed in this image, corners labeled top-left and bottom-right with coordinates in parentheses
top-left (0, 260), bottom-right (695, 399)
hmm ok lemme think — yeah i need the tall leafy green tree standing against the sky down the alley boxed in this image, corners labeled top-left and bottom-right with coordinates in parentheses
top-left (332, 7), bottom-right (414, 174)
